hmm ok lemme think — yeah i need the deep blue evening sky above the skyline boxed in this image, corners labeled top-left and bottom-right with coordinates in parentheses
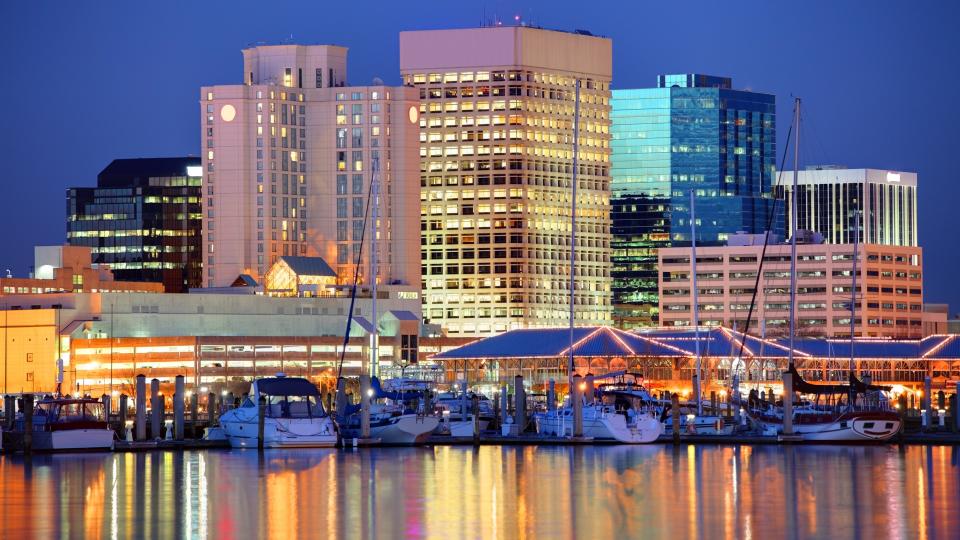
top-left (0, 0), bottom-right (960, 312)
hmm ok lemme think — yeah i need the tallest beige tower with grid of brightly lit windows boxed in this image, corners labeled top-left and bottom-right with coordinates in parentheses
top-left (400, 26), bottom-right (612, 336)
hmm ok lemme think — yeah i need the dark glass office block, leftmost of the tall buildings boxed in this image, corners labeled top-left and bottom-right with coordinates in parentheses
top-left (67, 157), bottom-right (201, 292)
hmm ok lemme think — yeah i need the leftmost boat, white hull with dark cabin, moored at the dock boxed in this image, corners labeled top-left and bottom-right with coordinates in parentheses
top-left (18, 398), bottom-right (115, 452)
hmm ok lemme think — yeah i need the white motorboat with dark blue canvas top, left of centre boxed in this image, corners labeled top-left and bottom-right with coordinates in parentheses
top-left (220, 374), bottom-right (337, 448)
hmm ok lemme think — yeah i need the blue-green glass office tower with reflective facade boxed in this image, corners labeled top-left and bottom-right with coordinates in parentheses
top-left (611, 74), bottom-right (782, 328)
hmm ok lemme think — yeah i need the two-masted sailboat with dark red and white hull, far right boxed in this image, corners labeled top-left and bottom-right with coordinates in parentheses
top-left (747, 98), bottom-right (902, 442)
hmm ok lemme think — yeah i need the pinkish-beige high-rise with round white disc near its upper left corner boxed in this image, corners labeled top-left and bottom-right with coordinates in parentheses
top-left (200, 45), bottom-right (420, 287)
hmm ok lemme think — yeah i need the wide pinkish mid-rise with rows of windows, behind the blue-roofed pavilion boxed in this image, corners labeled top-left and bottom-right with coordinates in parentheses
top-left (657, 240), bottom-right (924, 338)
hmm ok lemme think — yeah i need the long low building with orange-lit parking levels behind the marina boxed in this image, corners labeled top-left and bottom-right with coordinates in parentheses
top-left (0, 286), bottom-right (463, 396)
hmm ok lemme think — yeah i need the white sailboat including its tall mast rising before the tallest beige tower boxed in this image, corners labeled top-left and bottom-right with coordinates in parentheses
top-left (534, 79), bottom-right (663, 444)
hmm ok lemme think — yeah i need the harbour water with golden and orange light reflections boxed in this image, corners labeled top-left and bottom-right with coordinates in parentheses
top-left (0, 446), bottom-right (960, 539)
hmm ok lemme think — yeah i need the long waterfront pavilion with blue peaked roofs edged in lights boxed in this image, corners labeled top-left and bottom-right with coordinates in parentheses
top-left (431, 326), bottom-right (960, 390)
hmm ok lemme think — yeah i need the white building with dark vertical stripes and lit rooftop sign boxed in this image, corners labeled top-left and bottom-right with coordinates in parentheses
top-left (777, 166), bottom-right (918, 246)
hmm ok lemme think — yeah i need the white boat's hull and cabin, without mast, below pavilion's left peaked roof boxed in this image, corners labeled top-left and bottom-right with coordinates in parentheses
top-left (534, 403), bottom-right (663, 444)
